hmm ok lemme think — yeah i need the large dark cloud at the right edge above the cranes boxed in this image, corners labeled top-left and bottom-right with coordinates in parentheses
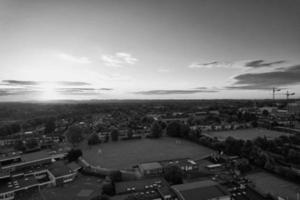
top-left (226, 65), bottom-right (300, 90)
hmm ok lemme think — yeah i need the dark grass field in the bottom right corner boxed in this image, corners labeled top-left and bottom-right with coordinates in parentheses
top-left (247, 172), bottom-right (300, 200)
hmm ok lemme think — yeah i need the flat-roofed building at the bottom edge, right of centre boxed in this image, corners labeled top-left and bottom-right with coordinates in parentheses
top-left (171, 180), bottom-right (230, 200)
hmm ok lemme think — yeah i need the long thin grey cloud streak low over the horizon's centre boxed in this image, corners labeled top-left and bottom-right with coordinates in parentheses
top-left (134, 89), bottom-right (218, 95)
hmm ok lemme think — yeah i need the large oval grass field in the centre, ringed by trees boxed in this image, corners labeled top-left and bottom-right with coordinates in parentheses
top-left (82, 137), bottom-right (213, 169)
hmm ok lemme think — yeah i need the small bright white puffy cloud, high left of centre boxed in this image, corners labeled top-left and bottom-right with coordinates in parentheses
top-left (101, 52), bottom-right (138, 67)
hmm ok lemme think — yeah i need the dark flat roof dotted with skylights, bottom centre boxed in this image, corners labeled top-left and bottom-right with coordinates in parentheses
top-left (115, 178), bottom-right (169, 194)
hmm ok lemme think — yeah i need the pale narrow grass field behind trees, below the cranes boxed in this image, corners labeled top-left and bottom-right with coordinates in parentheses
top-left (207, 128), bottom-right (289, 140)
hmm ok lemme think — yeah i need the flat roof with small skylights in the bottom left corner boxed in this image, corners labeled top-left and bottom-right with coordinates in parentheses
top-left (0, 176), bottom-right (38, 194)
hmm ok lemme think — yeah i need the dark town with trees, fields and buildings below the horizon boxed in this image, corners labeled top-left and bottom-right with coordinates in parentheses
top-left (0, 99), bottom-right (300, 200)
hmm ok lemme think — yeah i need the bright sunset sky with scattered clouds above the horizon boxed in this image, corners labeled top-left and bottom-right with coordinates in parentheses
top-left (0, 0), bottom-right (300, 101)
